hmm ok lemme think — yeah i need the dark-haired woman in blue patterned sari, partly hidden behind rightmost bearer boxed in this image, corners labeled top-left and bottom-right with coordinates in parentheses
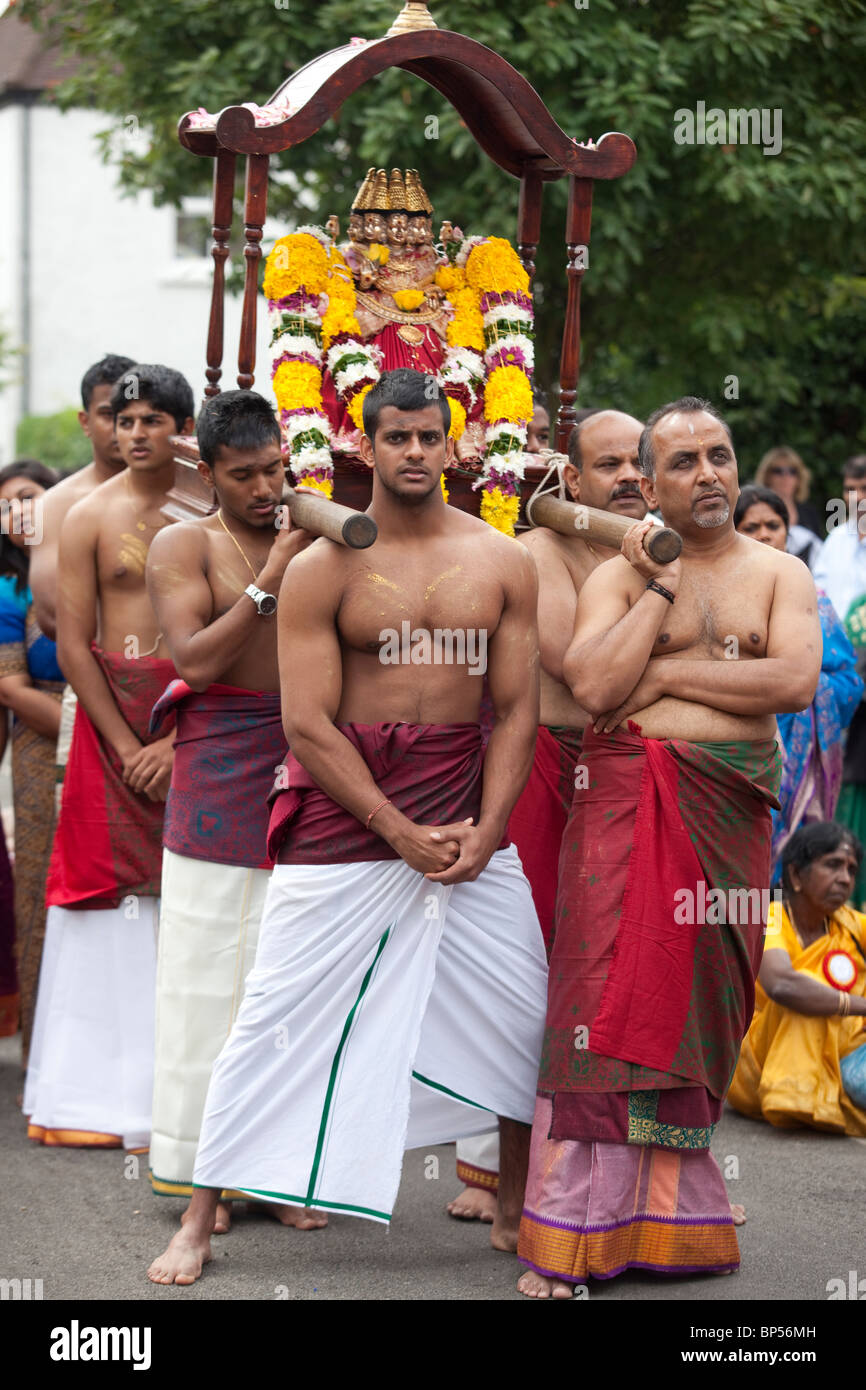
top-left (734, 487), bottom-right (863, 883)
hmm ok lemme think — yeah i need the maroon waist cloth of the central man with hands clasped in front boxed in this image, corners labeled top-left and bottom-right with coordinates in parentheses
top-left (268, 724), bottom-right (510, 865)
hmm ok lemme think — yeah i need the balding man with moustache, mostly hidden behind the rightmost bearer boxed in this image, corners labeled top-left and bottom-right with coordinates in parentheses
top-left (446, 402), bottom-right (646, 1223)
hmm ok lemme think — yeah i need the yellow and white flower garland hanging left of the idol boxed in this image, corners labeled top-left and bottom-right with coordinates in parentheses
top-left (264, 227), bottom-right (334, 498)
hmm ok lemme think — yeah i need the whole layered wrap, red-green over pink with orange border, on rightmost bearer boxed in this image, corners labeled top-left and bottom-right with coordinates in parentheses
top-left (518, 724), bottom-right (781, 1280)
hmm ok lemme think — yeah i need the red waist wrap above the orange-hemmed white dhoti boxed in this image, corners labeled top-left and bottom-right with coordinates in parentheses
top-left (46, 646), bottom-right (177, 908)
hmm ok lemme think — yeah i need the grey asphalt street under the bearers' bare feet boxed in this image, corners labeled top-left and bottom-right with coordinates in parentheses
top-left (0, 1038), bottom-right (866, 1301)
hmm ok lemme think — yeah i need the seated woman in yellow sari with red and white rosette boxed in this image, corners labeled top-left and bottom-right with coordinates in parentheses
top-left (728, 820), bottom-right (866, 1136)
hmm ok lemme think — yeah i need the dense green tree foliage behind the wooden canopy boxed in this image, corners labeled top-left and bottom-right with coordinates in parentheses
top-left (21, 0), bottom-right (866, 500)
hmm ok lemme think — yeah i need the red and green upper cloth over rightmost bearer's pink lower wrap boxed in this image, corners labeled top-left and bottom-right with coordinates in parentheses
top-left (539, 726), bottom-right (780, 1147)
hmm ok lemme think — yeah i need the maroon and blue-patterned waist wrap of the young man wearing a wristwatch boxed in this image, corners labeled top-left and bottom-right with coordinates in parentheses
top-left (150, 681), bottom-right (286, 869)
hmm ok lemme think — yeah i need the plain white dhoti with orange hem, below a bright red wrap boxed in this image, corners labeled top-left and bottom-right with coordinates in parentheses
top-left (24, 898), bottom-right (158, 1148)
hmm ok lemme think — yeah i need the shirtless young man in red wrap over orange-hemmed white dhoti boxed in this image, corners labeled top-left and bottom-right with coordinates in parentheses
top-left (24, 366), bottom-right (193, 1147)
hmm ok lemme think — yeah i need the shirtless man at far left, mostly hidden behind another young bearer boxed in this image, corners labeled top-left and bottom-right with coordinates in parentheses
top-left (29, 354), bottom-right (135, 639)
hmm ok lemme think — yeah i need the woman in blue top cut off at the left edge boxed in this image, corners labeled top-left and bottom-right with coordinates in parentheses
top-left (0, 459), bottom-right (63, 1065)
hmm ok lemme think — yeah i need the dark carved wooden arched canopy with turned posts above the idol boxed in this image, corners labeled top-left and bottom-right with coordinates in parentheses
top-left (178, 17), bottom-right (637, 449)
